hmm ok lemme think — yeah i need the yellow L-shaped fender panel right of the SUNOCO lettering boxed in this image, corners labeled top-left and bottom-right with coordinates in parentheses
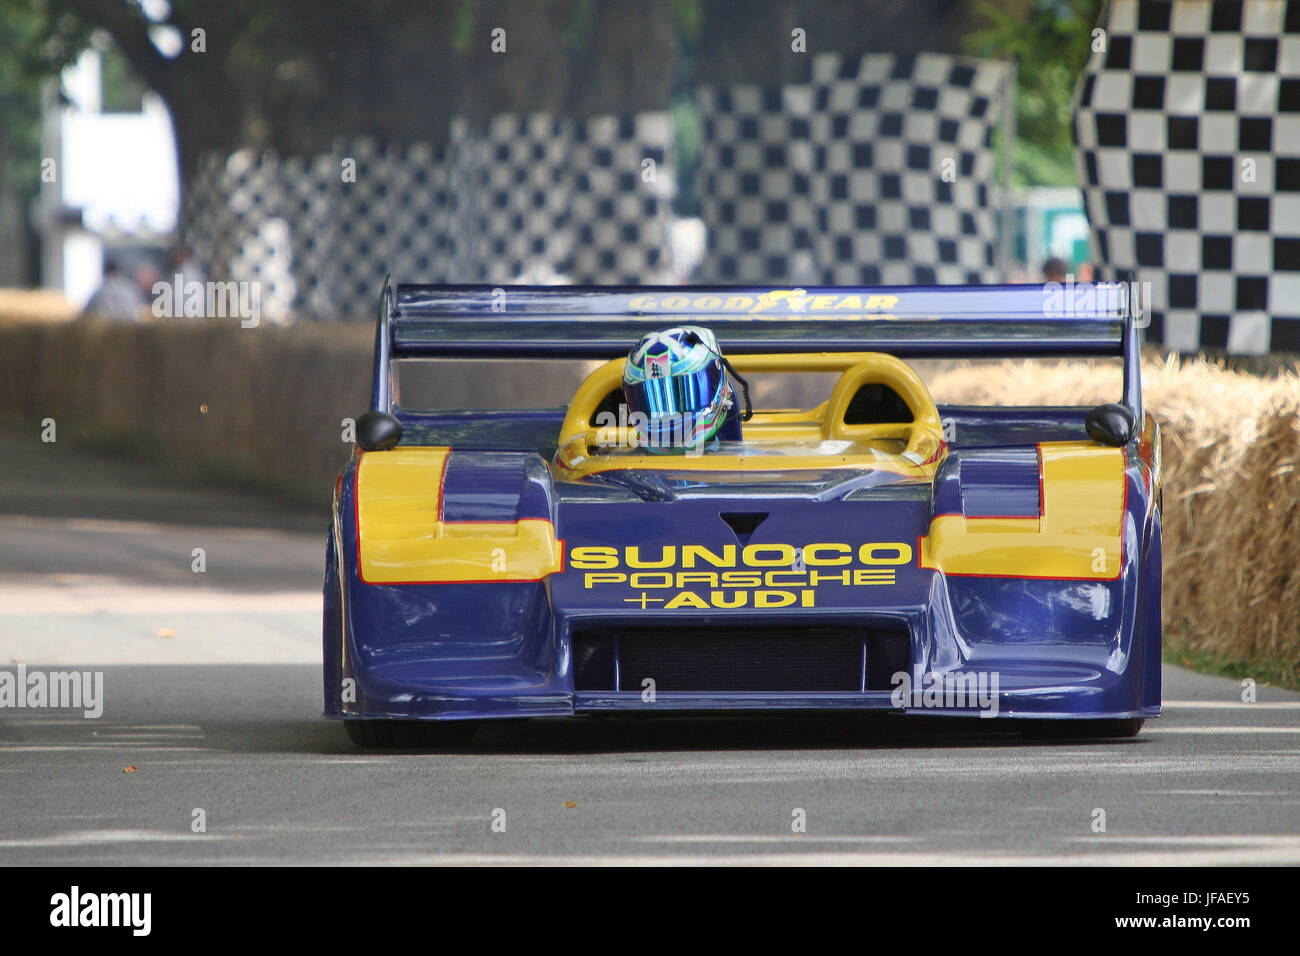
top-left (920, 441), bottom-right (1126, 580)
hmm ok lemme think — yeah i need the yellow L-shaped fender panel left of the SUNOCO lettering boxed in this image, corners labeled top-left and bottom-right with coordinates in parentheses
top-left (355, 447), bottom-right (562, 584)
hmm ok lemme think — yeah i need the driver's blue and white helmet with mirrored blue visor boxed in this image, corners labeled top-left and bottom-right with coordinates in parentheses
top-left (623, 325), bottom-right (740, 451)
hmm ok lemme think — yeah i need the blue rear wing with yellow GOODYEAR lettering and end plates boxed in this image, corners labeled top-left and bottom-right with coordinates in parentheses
top-left (371, 282), bottom-right (1141, 421)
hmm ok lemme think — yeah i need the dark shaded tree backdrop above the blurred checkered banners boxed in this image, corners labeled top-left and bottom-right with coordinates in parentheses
top-left (0, 0), bottom-right (1013, 208)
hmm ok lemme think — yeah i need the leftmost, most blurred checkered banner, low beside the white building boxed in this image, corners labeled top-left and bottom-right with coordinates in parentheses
top-left (182, 138), bottom-right (452, 320)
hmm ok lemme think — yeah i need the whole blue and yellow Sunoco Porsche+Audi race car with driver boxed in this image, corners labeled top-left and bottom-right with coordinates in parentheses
top-left (324, 284), bottom-right (1161, 747)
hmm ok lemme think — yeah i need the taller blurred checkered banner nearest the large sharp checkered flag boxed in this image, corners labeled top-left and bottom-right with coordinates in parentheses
top-left (813, 53), bottom-right (1013, 285)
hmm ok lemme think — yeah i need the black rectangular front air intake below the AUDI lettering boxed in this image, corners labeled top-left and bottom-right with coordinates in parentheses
top-left (573, 627), bottom-right (907, 693)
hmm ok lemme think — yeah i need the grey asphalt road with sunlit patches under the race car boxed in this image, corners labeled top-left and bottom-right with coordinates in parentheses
top-left (0, 441), bottom-right (1300, 865)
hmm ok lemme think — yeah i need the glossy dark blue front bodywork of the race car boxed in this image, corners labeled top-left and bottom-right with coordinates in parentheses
top-left (324, 411), bottom-right (1160, 718)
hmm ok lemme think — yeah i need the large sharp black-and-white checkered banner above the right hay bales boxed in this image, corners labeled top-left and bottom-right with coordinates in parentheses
top-left (1075, 0), bottom-right (1300, 354)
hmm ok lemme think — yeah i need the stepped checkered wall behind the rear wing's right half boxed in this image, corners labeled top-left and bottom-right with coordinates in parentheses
top-left (701, 53), bottom-right (1011, 285)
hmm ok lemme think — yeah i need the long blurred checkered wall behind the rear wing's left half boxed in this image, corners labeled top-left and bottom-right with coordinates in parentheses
top-left (183, 113), bottom-right (671, 319)
